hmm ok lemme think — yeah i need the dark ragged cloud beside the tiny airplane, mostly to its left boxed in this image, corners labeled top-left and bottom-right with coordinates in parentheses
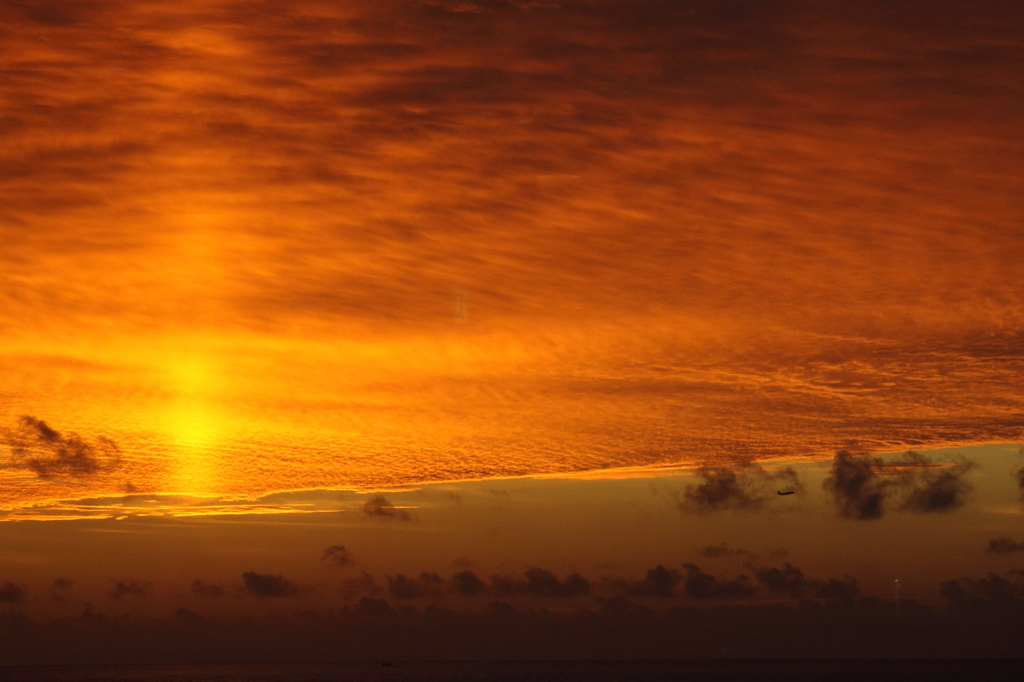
top-left (679, 464), bottom-right (804, 512)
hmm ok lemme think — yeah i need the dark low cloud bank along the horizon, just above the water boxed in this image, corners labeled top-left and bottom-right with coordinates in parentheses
top-left (0, 566), bottom-right (1024, 659)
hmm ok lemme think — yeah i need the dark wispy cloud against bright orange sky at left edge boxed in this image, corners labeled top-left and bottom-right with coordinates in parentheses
top-left (0, 415), bottom-right (121, 478)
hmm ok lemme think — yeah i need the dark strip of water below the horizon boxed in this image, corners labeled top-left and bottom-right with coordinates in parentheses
top-left (0, 659), bottom-right (1024, 682)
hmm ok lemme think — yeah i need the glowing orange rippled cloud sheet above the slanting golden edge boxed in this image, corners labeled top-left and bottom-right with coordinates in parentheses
top-left (0, 1), bottom-right (1024, 516)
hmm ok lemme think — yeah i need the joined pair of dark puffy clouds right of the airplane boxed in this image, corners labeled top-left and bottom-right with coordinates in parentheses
top-left (822, 451), bottom-right (975, 520)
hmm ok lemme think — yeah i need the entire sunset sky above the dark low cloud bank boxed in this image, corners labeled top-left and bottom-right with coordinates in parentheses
top-left (0, 0), bottom-right (1024, 657)
